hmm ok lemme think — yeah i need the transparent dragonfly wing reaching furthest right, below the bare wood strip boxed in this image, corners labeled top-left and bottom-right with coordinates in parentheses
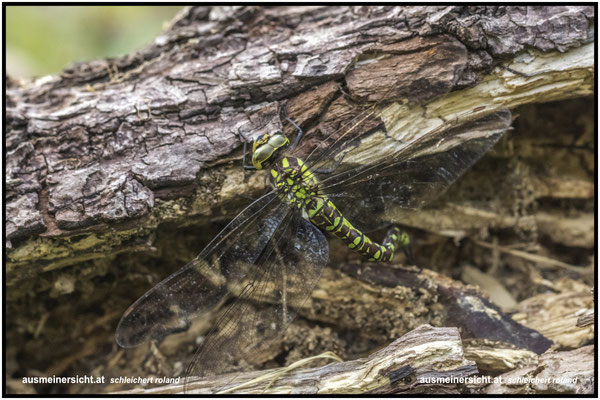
top-left (321, 110), bottom-right (512, 230)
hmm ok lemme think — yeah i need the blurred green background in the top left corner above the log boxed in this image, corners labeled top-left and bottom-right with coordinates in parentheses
top-left (5, 6), bottom-right (181, 78)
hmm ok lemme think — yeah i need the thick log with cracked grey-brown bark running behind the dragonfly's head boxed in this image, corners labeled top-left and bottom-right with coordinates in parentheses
top-left (7, 3), bottom-right (594, 272)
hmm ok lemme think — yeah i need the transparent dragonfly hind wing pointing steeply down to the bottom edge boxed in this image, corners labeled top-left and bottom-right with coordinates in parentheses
top-left (185, 212), bottom-right (328, 392)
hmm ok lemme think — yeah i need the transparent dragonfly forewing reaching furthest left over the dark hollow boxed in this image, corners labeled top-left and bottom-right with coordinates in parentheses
top-left (115, 192), bottom-right (289, 347)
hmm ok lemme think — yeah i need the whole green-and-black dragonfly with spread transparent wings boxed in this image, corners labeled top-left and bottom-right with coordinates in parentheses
top-left (115, 84), bottom-right (512, 391)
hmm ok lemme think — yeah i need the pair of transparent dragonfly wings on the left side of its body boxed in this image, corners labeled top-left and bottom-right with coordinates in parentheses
top-left (116, 188), bottom-right (328, 386)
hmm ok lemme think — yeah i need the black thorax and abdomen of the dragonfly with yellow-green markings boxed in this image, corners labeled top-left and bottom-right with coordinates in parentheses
top-left (271, 157), bottom-right (409, 262)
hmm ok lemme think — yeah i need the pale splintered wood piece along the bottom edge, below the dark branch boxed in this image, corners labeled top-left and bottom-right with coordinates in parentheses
top-left (118, 325), bottom-right (477, 395)
